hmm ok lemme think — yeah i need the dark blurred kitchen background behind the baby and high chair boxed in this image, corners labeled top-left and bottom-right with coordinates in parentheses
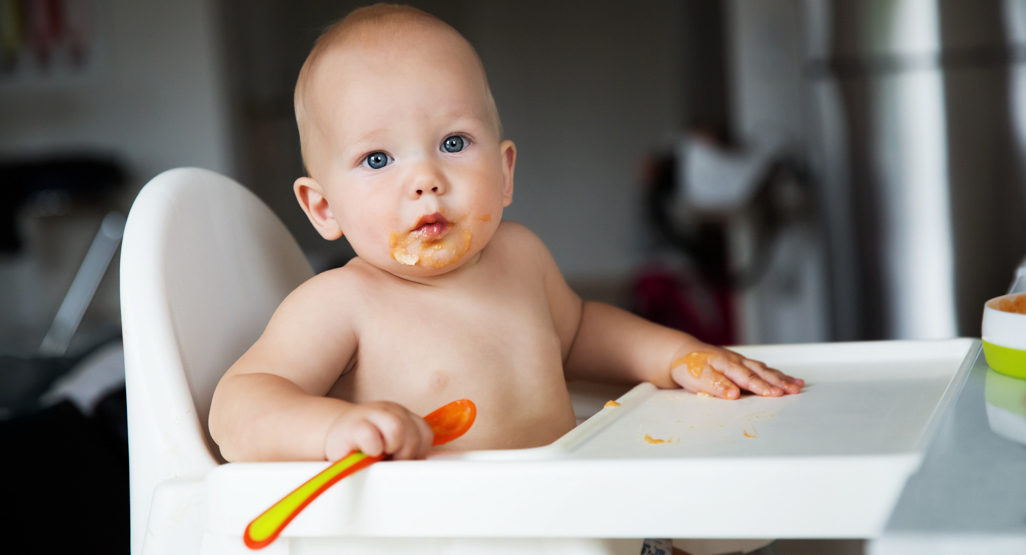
top-left (0, 0), bottom-right (1026, 550)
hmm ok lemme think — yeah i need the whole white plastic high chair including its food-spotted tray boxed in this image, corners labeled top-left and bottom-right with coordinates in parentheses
top-left (121, 168), bottom-right (979, 555)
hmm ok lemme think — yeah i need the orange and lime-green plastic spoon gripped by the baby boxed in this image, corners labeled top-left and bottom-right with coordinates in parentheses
top-left (242, 399), bottom-right (477, 549)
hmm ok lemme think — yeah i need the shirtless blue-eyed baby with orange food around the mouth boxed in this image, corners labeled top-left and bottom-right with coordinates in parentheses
top-left (209, 5), bottom-right (803, 461)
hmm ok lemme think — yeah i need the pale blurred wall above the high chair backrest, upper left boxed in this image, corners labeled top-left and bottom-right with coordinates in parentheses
top-left (0, 0), bottom-right (232, 175)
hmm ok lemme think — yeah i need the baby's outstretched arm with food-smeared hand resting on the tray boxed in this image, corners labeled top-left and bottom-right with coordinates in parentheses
top-left (538, 235), bottom-right (804, 399)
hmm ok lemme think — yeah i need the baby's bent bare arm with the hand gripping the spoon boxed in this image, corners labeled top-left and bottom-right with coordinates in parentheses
top-left (209, 273), bottom-right (433, 461)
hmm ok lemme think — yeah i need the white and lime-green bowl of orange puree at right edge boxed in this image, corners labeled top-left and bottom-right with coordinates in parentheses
top-left (983, 293), bottom-right (1026, 380)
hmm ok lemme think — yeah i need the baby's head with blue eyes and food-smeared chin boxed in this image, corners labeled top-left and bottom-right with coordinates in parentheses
top-left (293, 4), bottom-right (516, 277)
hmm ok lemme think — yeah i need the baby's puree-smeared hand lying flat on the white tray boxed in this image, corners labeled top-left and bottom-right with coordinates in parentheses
top-left (670, 344), bottom-right (805, 399)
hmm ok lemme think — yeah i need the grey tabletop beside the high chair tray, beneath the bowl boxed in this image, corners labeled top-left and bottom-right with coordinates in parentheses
top-left (868, 347), bottom-right (1026, 555)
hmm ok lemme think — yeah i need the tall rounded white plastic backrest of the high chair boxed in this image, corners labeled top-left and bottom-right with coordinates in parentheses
top-left (121, 168), bottom-right (313, 553)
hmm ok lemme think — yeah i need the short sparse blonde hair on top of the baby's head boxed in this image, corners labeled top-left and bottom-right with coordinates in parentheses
top-left (292, 3), bottom-right (503, 172)
